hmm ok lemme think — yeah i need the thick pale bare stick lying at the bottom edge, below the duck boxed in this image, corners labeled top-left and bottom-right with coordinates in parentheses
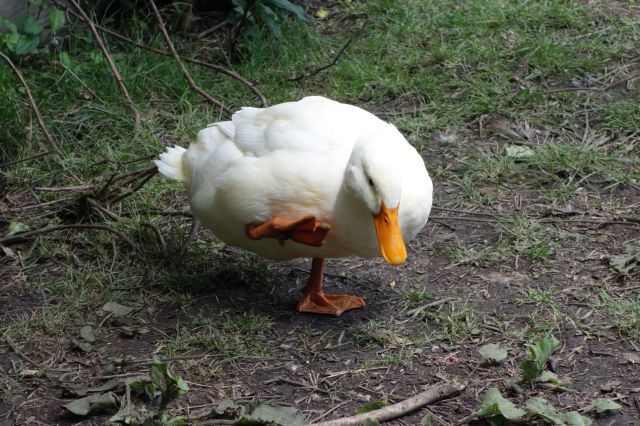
top-left (313, 384), bottom-right (465, 426)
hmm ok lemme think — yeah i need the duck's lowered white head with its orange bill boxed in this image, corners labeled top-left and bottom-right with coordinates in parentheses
top-left (345, 126), bottom-right (407, 265)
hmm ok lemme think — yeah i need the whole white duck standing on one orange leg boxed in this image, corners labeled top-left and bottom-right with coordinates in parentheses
top-left (155, 96), bottom-right (433, 315)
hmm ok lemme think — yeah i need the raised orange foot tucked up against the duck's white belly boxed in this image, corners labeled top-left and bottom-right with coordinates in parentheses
top-left (244, 215), bottom-right (330, 247)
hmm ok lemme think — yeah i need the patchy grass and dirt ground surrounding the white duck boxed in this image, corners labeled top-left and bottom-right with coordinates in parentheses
top-left (0, 0), bottom-right (640, 425)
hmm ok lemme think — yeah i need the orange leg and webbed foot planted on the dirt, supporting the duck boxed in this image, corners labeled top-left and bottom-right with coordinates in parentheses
top-left (298, 257), bottom-right (364, 317)
